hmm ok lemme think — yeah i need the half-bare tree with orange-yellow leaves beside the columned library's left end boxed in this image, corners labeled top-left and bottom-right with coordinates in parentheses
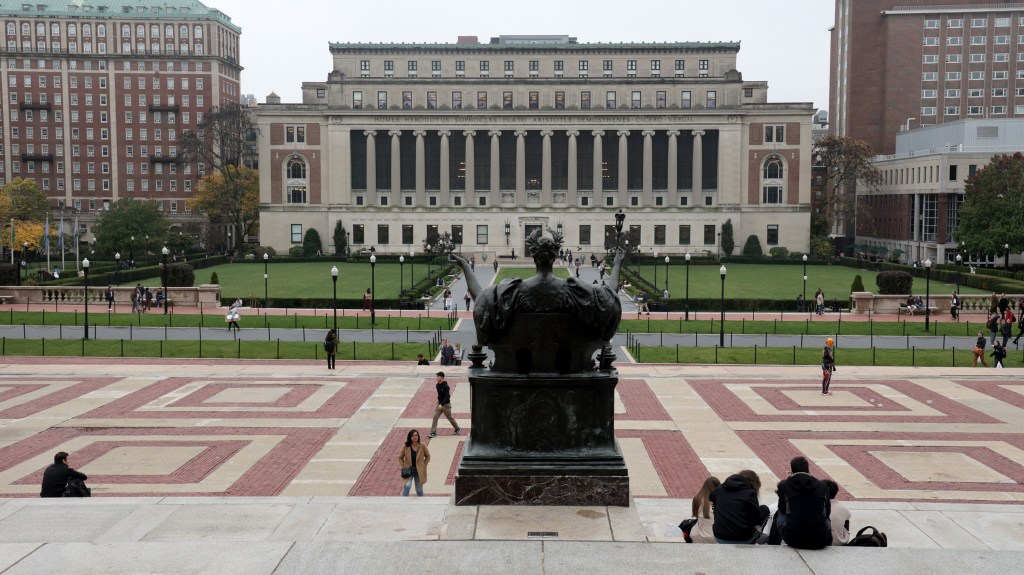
top-left (178, 102), bottom-right (259, 250)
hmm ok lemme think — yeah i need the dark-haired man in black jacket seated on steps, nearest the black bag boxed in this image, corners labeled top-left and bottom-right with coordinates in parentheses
top-left (772, 456), bottom-right (831, 549)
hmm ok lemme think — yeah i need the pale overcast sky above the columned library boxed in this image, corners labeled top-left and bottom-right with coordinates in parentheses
top-left (211, 0), bottom-right (835, 108)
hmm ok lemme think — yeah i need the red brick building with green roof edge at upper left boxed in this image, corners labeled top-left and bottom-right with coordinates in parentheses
top-left (0, 0), bottom-right (242, 240)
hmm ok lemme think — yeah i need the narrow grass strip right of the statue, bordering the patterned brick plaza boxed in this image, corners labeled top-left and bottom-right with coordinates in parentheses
top-left (633, 346), bottom-right (1024, 366)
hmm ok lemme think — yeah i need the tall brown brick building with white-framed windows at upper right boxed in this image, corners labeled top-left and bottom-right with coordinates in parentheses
top-left (829, 0), bottom-right (1024, 154)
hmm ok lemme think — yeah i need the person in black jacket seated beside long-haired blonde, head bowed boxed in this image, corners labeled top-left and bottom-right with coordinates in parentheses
top-left (711, 470), bottom-right (769, 543)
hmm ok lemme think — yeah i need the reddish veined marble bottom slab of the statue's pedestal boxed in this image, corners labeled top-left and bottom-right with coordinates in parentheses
top-left (455, 470), bottom-right (630, 501)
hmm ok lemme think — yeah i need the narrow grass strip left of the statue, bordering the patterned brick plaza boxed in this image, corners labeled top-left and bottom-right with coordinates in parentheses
top-left (0, 338), bottom-right (433, 362)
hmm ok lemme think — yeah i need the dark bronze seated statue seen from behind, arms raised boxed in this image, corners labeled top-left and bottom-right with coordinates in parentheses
top-left (453, 228), bottom-right (626, 373)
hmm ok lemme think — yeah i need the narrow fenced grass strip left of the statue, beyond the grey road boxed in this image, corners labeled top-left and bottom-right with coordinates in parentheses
top-left (0, 305), bottom-right (452, 331)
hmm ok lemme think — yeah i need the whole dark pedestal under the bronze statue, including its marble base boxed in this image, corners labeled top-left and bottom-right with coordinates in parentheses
top-left (455, 367), bottom-right (630, 506)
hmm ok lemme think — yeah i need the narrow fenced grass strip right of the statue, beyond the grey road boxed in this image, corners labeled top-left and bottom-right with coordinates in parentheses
top-left (618, 312), bottom-right (1003, 337)
